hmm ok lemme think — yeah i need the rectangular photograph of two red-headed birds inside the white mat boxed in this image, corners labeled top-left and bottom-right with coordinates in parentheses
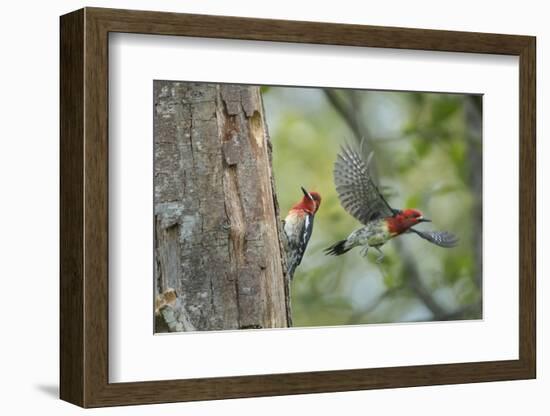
top-left (153, 80), bottom-right (483, 333)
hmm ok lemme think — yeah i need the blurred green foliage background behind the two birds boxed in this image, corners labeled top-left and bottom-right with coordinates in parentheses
top-left (262, 87), bottom-right (481, 326)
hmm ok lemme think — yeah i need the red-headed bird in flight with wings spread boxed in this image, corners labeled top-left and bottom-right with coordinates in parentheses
top-left (325, 146), bottom-right (458, 263)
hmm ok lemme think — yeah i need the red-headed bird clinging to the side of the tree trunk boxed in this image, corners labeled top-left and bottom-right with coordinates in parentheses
top-left (284, 187), bottom-right (321, 278)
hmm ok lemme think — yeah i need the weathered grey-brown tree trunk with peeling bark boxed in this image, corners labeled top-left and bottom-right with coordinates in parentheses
top-left (154, 81), bottom-right (290, 332)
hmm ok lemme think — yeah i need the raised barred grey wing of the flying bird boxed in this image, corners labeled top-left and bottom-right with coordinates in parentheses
top-left (334, 146), bottom-right (395, 224)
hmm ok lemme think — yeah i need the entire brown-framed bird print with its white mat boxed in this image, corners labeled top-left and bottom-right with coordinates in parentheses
top-left (60, 8), bottom-right (536, 407)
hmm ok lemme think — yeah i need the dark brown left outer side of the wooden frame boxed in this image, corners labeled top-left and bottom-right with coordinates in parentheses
top-left (59, 10), bottom-right (85, 404)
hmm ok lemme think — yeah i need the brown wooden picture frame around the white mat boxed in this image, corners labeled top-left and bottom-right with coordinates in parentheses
top-left (60, 8), bottom-right (536, 407)
